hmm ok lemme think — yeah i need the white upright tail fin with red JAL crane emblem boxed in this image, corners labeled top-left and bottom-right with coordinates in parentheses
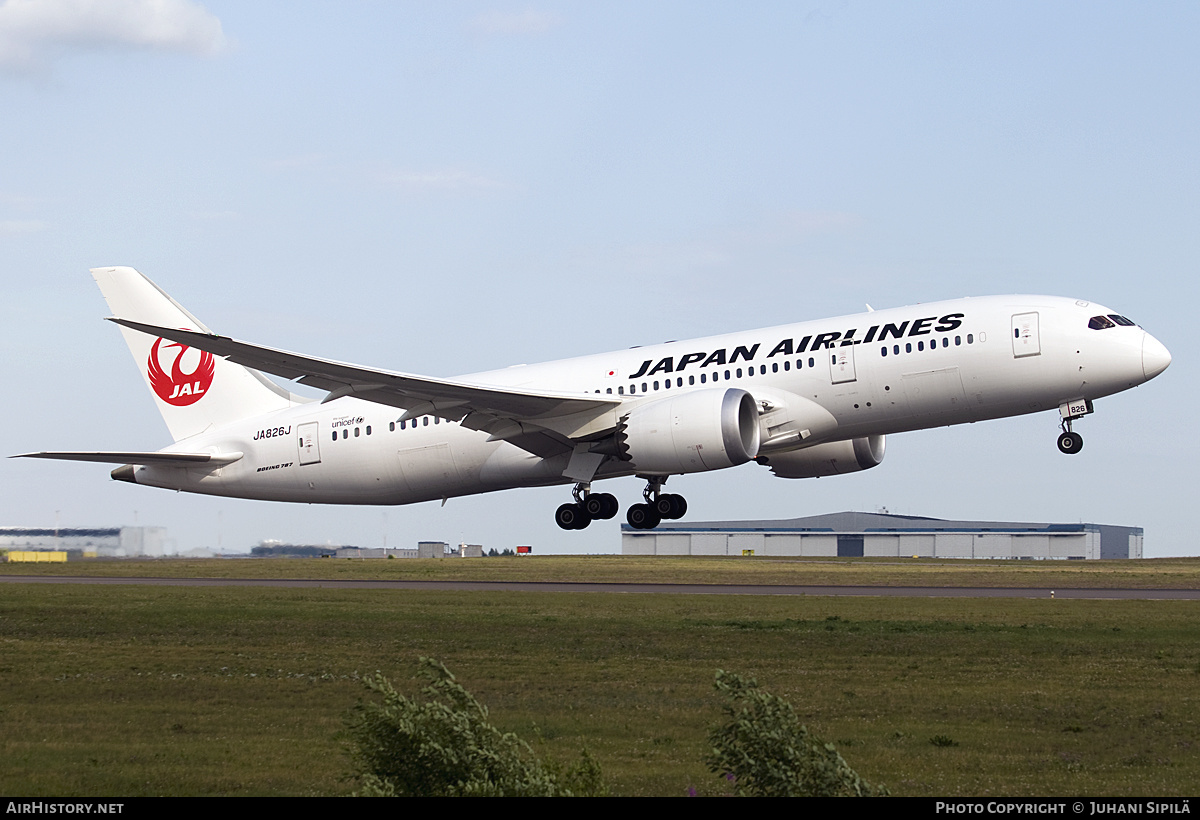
top-left (91, 268), bottom-right (302, 442)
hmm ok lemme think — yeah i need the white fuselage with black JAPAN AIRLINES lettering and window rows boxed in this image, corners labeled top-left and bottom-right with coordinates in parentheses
top-left (126, 291), bottom-right (1170, 504)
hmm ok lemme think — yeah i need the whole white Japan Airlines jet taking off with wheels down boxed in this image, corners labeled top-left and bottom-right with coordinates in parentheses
top-left (14, 268), bottom-right (1171, 529)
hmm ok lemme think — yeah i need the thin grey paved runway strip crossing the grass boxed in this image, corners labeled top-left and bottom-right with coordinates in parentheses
top-left (0, 575), bottom-right (1200, 600)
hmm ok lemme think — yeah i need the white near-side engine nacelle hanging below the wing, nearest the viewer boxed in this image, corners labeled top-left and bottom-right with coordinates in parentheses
top-left (623, 388), bottom-right (760, 475)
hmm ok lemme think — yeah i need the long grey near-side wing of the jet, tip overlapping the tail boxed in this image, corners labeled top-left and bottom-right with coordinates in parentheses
top-left (109, 318), bottom-right (622, 455)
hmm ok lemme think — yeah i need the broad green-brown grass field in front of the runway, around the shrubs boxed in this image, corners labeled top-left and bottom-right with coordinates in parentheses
top-left (0, 558), bottom-right (1200, 796)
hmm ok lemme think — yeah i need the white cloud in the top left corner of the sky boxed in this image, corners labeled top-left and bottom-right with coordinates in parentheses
top-left (0, 0), bottom-right (227, 68)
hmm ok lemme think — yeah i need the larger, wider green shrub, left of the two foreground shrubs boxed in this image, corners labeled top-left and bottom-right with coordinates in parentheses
top-left (349, 658), bottom-right (605, 797)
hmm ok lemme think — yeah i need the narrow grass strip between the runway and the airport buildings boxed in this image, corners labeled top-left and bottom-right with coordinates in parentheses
top-left (7, 555), bottom-right (1200, 589)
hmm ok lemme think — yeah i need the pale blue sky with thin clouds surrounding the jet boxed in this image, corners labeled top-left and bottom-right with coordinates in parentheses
top-left (0, 0), bottom-right (1200, 556)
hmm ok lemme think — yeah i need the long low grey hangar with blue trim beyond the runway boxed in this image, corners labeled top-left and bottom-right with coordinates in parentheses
top-left (620, 513), bottom-right (1144, 561)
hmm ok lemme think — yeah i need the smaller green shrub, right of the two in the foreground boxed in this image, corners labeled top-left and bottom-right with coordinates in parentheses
top-left (706, 671), bottom-right (888, 797)
